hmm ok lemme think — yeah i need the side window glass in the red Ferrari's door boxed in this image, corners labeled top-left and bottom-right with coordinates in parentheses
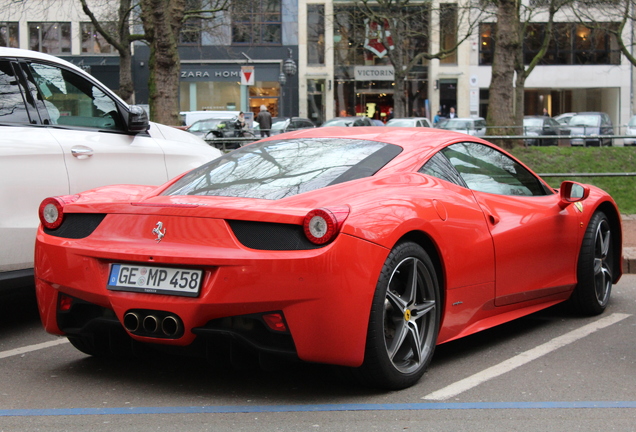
top-left (441, 143), bottom-right (548, 196)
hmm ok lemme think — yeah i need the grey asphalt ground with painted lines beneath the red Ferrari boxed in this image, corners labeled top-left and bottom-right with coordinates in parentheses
top-left (0, 275), bottom-right (636, 432)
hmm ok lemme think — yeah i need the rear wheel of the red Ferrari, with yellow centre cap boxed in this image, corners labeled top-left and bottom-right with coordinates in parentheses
top-left (358, 242), bottom-right (441, 390)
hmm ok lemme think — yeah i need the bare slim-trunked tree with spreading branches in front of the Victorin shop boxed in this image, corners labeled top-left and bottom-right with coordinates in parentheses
top-left (334, 0), bottom-right (483, 117)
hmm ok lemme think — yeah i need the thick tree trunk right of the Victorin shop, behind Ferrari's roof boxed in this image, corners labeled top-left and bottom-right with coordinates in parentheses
top-left (487, 0), bottom-right (521, 147)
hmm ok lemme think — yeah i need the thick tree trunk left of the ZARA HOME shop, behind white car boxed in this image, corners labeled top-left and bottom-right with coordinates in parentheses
top-left (140, 0), bottom-right (185, 125)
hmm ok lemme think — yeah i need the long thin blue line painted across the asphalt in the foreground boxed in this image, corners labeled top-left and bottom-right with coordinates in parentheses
top-left (0, 401), bottom-right (636, 417)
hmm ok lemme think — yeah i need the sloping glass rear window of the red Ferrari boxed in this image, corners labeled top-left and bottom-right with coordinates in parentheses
top-left (163, 138), bottom-right (402, 200)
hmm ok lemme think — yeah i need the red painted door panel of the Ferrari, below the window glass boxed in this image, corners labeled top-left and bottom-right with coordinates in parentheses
top-left (474, 191), bottom-right (581, 306)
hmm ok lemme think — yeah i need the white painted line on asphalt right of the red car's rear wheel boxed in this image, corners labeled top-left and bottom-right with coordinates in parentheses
top-left (422, 313), bottom-right (631, 400)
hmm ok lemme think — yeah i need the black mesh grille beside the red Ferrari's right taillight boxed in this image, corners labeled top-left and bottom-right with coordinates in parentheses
top-left (227, 220), bottom-right (326, 250)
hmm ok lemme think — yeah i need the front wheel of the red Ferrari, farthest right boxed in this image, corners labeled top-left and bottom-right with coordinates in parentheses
top-left (570, 211), bottom-right (614, 315)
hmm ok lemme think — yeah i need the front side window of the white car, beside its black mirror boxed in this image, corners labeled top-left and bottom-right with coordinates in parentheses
top-left (24, 63), bottom-right (123, 130)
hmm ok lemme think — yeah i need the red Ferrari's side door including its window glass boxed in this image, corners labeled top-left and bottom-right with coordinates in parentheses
top-left (442, 142), bottom-right (582, 306)
